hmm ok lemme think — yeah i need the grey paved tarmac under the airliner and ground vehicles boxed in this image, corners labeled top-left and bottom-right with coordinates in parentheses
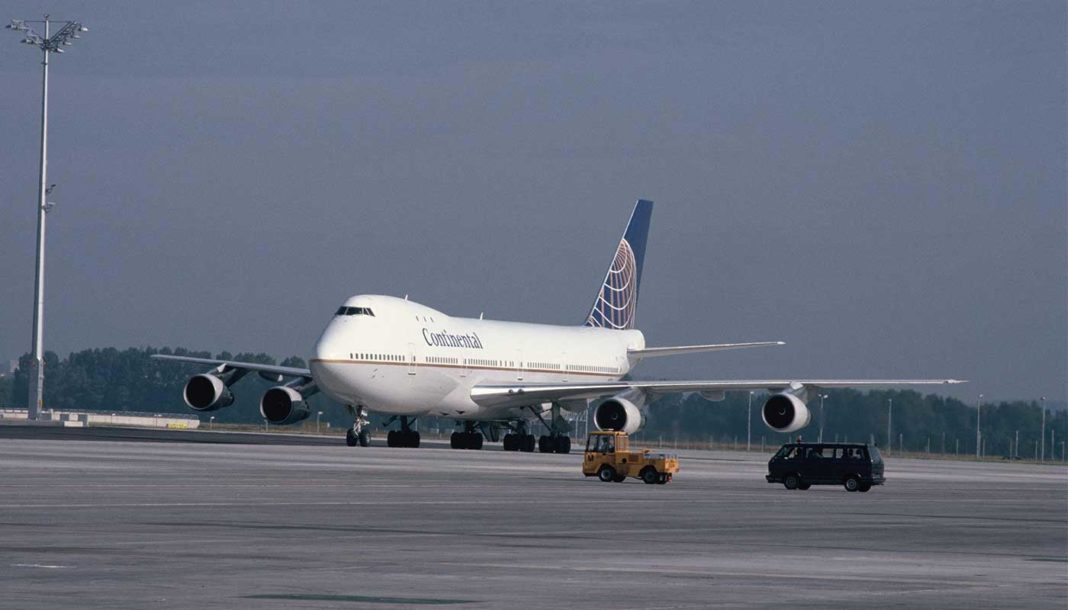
top-left (0, 428), bottom-right (1068, 610)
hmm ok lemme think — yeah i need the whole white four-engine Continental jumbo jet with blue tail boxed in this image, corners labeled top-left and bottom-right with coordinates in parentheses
top-left (154, 199), bottom-right (963, 453)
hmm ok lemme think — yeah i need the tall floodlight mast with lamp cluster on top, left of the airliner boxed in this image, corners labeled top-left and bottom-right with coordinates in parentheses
top-left (7, 15), bottom-right (89, 421)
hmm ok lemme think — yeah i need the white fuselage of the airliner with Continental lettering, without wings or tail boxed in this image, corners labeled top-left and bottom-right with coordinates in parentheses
top-left (310, 295), bottom-right (645, 420)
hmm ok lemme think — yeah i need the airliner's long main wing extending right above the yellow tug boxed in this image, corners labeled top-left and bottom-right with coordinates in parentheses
top-left (471, 379), bottom-right (964, 407)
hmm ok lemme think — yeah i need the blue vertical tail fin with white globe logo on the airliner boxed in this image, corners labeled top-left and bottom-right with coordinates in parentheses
top-left (586, 199), bottom-right (653, 330)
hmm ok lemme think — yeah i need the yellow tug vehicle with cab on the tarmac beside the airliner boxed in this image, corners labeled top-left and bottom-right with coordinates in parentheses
top-left (582, 431), bottom-right (678, 485)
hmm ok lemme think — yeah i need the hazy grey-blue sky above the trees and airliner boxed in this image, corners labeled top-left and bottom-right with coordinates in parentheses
top-left (0, 0), bottom-right (1068, 401)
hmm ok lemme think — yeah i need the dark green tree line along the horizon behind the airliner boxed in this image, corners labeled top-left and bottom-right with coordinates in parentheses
top-left (0, 347), bottom-right (1068, 458)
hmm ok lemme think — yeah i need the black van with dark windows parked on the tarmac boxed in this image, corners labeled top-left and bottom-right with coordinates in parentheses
top-left (766, 442), bottom-right (885, 491)
